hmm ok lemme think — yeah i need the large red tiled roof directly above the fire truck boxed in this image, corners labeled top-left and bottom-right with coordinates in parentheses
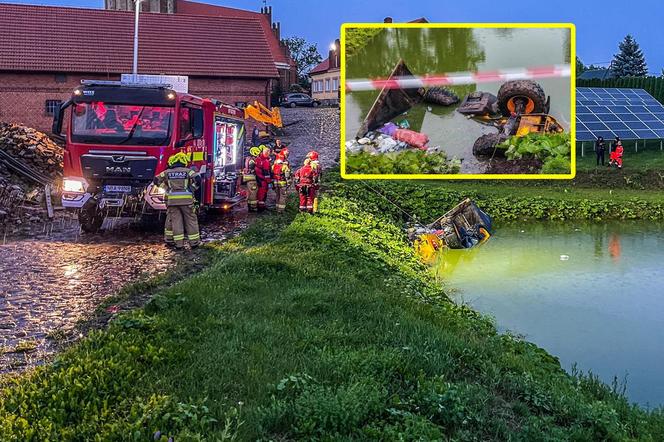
top-left (0, 4), bottom-right (278, 78)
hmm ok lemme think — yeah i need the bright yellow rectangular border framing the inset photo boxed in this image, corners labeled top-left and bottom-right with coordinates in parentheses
top-left (340, 23), bottom-right (576, 180)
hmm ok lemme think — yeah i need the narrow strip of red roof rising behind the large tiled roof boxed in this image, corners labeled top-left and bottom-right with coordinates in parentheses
top-left (176, 0), bottom-right (293, 65)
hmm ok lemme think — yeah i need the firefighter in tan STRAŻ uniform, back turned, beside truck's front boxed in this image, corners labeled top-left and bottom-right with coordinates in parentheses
top-left (154, 152), bottom-right (201, 249)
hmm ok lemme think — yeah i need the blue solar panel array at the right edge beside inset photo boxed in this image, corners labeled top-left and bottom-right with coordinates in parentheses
top-left (576, 87), bottom-right (664, 141)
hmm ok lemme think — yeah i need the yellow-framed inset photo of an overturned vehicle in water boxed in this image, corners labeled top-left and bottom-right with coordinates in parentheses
top-left (341, 23), bottom-right (575, 179)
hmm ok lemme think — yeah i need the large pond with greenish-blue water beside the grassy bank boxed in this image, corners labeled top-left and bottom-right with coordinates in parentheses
top-left (434, 222), bottom-right (664, 406)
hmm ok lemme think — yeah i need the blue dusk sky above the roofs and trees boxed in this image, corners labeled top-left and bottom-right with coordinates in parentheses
top-left (2, 0), bottom-right (664, 75)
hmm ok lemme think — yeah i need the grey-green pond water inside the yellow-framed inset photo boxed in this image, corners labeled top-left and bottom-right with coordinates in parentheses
top-left (346, 28), bottom-right (570, 173)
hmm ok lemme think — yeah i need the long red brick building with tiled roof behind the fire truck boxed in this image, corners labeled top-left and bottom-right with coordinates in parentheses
top-left (0, 0), bottom-right (294, 131)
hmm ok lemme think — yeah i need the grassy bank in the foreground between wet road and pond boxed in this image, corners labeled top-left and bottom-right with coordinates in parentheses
top-left (0, 183), bottom-right (664, 441)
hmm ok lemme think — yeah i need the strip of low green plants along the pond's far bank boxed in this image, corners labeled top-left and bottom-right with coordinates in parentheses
top-left (336, 177), bottom-right (664, 223)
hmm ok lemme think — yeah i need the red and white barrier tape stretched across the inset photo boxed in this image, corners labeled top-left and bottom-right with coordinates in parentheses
top-left (346, 64), bottom-right (572, 92)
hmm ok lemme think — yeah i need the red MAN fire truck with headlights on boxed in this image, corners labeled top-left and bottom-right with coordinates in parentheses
top-left (53, 81), bottom-right (245, 232)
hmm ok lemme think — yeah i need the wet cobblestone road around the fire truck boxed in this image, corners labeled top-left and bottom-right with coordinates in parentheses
top-left (0, 108), bottom-right (339, 373)
